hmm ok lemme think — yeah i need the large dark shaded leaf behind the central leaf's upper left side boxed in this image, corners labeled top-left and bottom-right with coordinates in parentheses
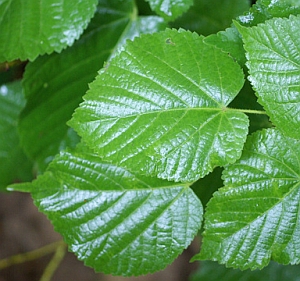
top-left (19, 0), bottom-right (164, 170)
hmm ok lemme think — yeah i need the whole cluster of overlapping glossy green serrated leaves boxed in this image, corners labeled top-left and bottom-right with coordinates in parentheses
top-left (0, 0), bottom-right (300, 280)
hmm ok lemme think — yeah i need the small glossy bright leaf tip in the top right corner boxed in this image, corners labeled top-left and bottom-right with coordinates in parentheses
top-left (238, 0), bottom-right (300, 26)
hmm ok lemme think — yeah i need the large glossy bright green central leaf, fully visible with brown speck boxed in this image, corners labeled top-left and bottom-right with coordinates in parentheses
top-left (69, 30), bottom-right (248, 182)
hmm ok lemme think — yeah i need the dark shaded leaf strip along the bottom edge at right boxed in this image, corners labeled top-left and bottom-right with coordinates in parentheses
top-left (189, 261), bottom-right (300, 281)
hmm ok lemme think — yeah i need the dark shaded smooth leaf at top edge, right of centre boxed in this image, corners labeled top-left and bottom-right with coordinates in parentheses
top-left (172, 0), bottom-right (250, 35)
